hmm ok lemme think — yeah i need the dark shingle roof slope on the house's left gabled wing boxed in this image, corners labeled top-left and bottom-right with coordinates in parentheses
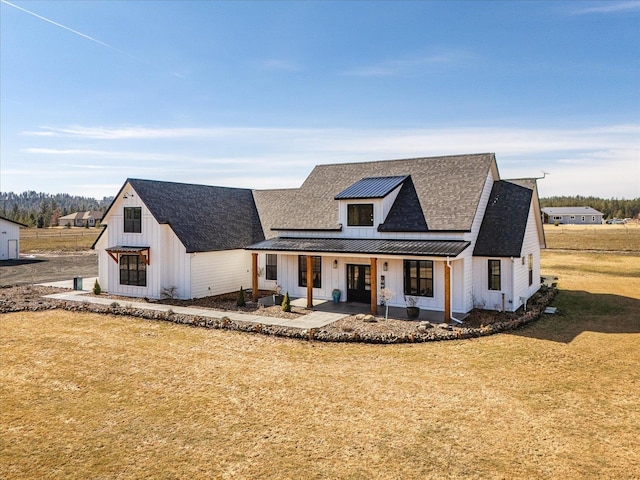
top-left (127, 179), bottom-right (264, 253)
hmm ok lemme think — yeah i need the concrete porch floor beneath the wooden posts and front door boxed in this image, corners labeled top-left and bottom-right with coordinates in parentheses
top-left (258, 296), bottom-right (467, 323)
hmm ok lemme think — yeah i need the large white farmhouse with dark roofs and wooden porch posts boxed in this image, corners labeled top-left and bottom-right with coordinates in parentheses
top-left (94, 153), bottom-right (545, 318)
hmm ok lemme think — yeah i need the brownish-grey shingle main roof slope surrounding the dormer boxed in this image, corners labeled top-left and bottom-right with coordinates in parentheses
top-left (264, 153), bottom-right (498, 231)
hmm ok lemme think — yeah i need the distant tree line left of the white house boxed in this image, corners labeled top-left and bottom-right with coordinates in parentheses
top-left (0, 191), bottom-right (113, 228)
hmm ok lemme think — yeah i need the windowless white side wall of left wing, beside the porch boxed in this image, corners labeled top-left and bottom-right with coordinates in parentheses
top-left (190, 250), bottom-right (252, 298)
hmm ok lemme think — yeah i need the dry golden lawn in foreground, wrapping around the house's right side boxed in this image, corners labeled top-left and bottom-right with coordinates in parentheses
top-left (0, 227), bottom-right (640, 479)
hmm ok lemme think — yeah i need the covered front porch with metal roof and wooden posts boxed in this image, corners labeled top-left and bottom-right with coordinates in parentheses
top-left (247, 237), bottom-right (469, 321)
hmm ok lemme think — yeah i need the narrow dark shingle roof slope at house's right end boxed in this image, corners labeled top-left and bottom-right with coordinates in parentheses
top-left (473, 180), bottom-right (533, 257)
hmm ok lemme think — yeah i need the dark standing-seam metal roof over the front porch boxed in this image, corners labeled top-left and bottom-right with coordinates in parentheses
top-left (246, 237), bottom-right (471, 257)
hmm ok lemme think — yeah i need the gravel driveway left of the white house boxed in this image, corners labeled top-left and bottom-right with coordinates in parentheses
top-left (0, 250), bottom-right (98, 287)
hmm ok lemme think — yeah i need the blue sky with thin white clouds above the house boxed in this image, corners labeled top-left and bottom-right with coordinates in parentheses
top-left (0, 0), bottom-right (640, 198)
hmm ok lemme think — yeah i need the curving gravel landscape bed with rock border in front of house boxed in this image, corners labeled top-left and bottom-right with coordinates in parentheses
top-left (0, 286), bottom-right (557, 344)
